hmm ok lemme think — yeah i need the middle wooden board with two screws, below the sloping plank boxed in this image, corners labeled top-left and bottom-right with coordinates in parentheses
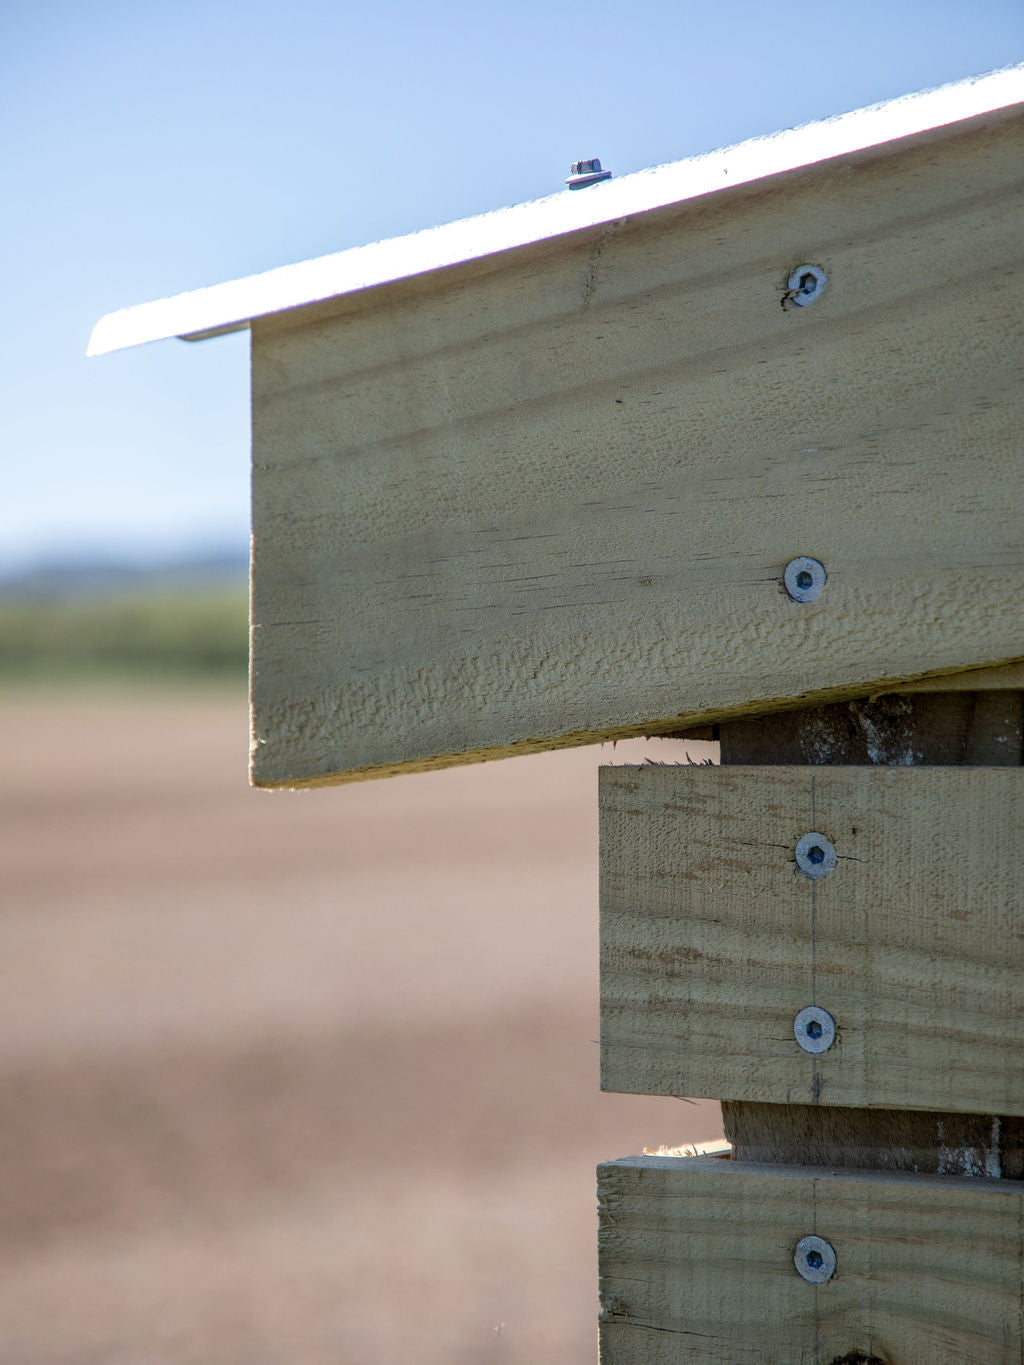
top-left (601, 766), bottom-right (1024, 1115)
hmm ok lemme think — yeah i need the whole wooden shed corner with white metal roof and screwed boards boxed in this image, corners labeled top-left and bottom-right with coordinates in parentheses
top-left (90, 67), bottom-right (1024, 1365)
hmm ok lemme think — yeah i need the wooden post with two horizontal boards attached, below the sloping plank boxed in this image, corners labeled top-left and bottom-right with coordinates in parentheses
top-left (599, 691), bottom-right (1024, 1365)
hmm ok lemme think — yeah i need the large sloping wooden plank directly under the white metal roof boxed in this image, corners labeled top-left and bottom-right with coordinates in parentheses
top-left (253, 108), bottom-right (1024, 786)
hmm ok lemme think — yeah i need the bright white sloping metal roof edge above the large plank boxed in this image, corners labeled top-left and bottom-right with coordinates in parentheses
top-left (86, 63), bottom-right (1024, 355)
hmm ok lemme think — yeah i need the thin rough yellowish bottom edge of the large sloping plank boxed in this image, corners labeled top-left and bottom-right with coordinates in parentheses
top-left (248, 658), bottom-right (1024, 792)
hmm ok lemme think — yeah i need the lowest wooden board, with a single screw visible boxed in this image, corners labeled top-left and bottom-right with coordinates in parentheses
top-left (598, 1156), bottom-right (1024, 1365)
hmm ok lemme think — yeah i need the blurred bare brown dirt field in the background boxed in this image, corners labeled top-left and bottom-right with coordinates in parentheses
top-left (0, 688), bottom-right (721, 1365)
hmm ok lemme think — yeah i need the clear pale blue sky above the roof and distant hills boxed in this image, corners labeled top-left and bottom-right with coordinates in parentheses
top-left (0, 0), bottom-right (1024, 569)
